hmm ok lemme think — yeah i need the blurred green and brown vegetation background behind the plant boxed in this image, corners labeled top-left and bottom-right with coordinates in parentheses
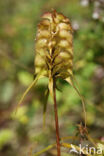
top-left (0, 0), bottom-right (104, 156)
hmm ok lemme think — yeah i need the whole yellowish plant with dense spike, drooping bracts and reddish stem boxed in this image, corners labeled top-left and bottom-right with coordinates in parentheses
top-left (15, 10), bottom-right (86, 156)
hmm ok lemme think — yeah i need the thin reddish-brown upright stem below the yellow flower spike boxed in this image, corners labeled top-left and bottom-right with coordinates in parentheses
top-left (53, 80), bottom-right (61, 156)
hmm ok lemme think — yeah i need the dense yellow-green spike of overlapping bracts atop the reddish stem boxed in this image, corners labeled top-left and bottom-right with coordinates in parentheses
top-left (35, 11), bottom-right (73, 86)
